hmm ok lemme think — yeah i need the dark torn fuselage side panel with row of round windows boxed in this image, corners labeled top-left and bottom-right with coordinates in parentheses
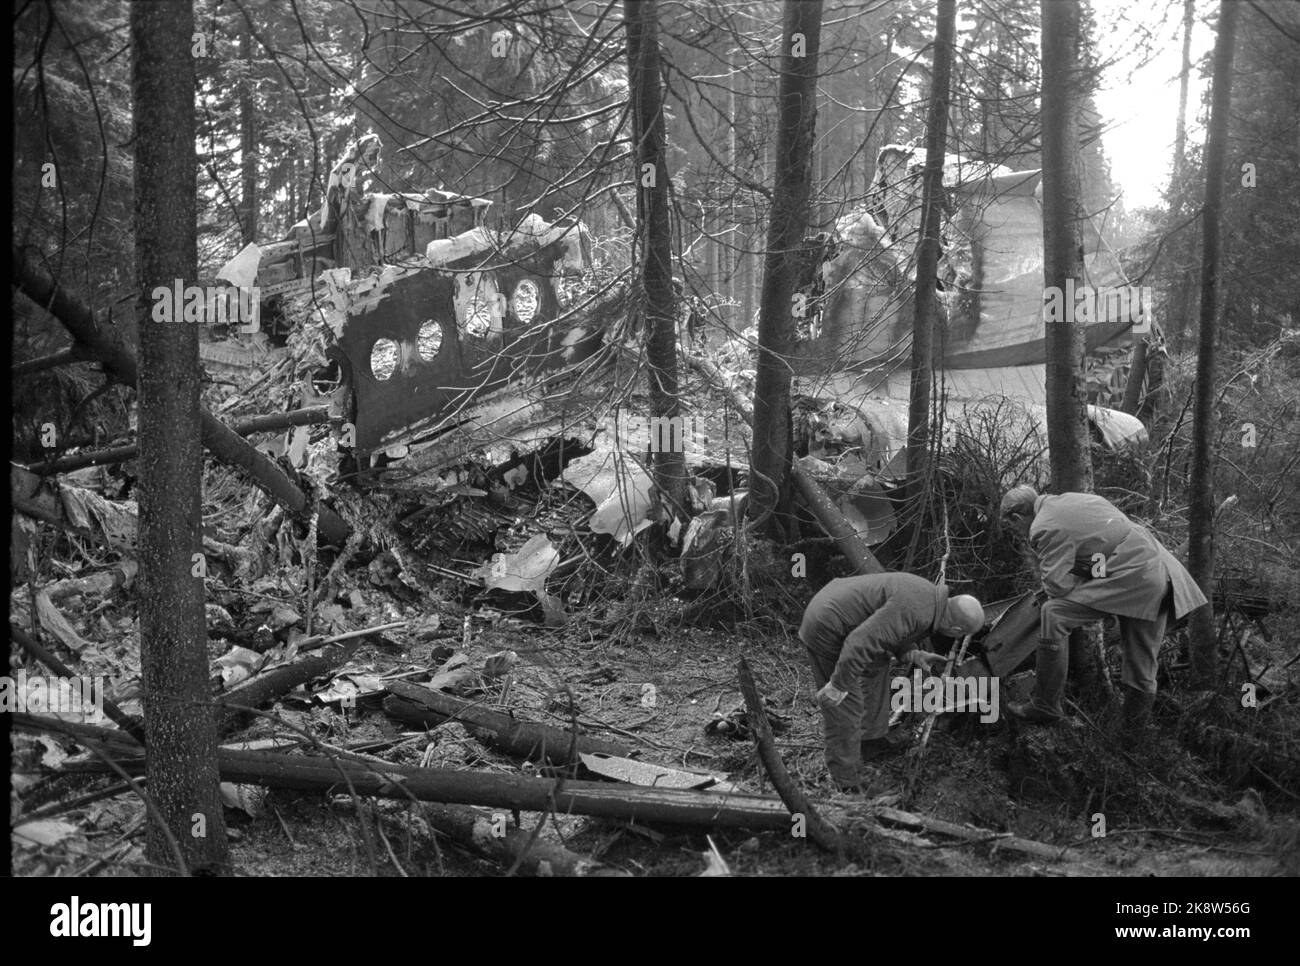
top-left (329, 211), bottom-right (603, 465)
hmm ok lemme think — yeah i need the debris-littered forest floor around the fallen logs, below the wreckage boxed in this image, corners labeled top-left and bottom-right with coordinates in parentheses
top-left (10, 325), bottom-right (1300, 876)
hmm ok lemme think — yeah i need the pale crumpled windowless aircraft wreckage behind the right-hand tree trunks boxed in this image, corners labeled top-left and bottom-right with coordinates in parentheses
top-left (774, 146), bottom-right (1157, 478)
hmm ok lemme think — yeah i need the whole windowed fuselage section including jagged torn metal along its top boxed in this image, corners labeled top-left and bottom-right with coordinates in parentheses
top-left (221, 135), bottom-right (602, 478)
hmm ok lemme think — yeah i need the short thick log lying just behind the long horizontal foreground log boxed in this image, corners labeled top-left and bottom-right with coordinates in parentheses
top-left (384, 681), bottom-right (629, 764)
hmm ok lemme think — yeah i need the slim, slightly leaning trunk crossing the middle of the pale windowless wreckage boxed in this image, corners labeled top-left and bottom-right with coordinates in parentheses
top-left (907, 0), bottom-right (957, 507)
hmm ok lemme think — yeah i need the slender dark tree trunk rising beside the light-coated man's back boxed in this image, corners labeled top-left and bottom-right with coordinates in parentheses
top-left (1187, 0), bottom-right (1238, 686)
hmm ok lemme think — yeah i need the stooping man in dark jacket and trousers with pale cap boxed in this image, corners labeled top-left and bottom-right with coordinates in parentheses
top-left (800, 573), bottom-right (984, 789)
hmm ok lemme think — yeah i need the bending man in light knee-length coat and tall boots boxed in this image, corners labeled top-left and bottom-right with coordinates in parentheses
top-left (1001, 486), bottom-right (1206, 735)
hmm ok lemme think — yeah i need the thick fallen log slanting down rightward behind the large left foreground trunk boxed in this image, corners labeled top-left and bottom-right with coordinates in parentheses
top-left (13, 247), bottom-right (351, 546)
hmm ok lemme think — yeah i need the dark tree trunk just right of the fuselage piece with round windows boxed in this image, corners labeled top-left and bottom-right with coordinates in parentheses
top-left (623, 0), bottom-right (686, 515)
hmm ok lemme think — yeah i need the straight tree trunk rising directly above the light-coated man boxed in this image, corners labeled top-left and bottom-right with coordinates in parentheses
top-left (1041, 0), bottom-right (1092, 493)
